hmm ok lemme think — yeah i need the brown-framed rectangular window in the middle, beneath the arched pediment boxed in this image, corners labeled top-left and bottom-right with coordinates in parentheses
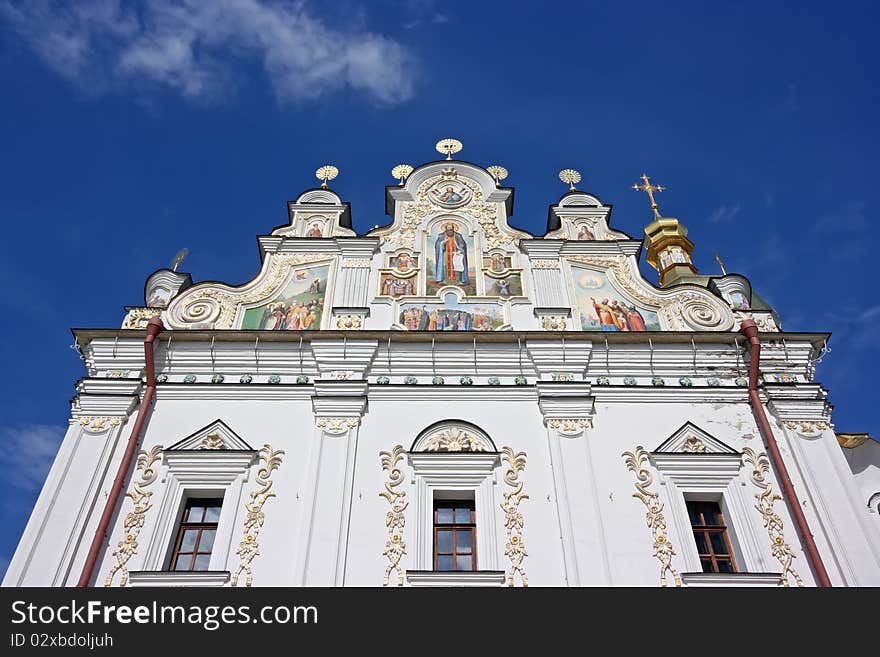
top-left (434, 499), bottom-right (477, 571)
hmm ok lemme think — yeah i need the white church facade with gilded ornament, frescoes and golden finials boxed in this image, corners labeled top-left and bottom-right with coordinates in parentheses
top-left (3, 146), bottom-right (880, 587)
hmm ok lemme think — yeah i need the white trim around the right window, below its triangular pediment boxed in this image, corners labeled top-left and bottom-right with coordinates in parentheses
top-left (651, 452), bottom-right (767, 574)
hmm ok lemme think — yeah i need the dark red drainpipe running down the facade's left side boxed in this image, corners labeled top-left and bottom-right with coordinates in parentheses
top-left (76, 317), bottom-right (164, 587)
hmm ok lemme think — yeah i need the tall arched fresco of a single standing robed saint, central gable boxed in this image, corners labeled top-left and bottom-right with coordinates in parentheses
top-left (426, 220), bottom-right (477, 295)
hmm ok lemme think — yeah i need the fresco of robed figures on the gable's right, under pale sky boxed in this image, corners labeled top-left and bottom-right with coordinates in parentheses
top-left (572, 267), bottom-right (660, 331)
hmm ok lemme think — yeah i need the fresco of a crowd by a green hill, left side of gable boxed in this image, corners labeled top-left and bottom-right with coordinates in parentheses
top-left (241, 265), bottom-right (330, 331)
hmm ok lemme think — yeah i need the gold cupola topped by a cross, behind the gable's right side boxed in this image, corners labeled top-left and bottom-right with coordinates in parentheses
top-left (633, 174), bottom-right (697, 287)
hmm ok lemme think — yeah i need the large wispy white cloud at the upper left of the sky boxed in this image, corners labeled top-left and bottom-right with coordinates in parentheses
top-left (0, 0), bottom-right (415, 104)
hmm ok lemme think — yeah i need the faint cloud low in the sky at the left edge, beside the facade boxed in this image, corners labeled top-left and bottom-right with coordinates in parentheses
top-left (0, 424), bottom-right (65, 491)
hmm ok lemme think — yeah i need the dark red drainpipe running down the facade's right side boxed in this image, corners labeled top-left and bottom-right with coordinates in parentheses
top-left (740, 319), bottom-right (831, 586)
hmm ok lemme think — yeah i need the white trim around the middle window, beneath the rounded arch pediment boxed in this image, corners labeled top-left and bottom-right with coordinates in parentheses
top-left (407, 452), bottom-right (501, 572)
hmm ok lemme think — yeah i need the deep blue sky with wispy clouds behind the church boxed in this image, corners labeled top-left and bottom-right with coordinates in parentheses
top-left (0, 0), bottom-right (880, 571)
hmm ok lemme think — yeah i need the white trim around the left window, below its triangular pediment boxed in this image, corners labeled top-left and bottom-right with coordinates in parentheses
top-left (141, 449), bottom-right (256, 581)
